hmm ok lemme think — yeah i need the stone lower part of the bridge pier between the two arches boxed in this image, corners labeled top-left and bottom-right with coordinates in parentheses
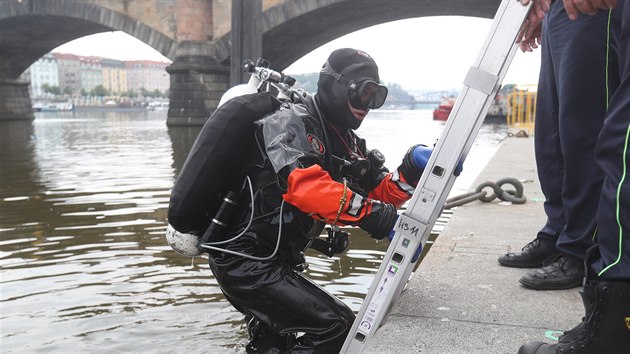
top-left (166, 42), bottom-right (230, 126)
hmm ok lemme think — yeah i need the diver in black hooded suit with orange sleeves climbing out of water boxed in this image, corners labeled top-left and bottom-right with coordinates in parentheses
top-left (198, 48), bottom-right (431, 353)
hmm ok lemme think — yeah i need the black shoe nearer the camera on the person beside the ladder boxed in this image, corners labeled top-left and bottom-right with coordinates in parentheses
top-left (519, 254), bottom-right (584, 290)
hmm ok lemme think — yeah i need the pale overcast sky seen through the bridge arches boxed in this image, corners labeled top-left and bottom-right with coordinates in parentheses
top-left (53, 16), bottom-right (540, 91)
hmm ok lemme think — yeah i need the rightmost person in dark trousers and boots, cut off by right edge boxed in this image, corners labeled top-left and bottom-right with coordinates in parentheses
top-left (518, 0), bottom-right (630, 354)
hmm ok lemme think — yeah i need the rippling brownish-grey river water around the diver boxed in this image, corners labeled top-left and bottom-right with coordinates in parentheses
top-left (0, 109), bottom-right (507, 353)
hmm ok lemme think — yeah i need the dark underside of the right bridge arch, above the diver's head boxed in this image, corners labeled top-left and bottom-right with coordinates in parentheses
top-left (215, 0), bottom-right (500, 70)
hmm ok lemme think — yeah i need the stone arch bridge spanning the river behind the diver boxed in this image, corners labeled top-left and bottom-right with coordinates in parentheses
top-left (0, 0), bottom-right (500, 125)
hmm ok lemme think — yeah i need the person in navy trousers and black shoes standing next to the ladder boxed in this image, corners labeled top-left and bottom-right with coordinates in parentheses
top-left (498, 0), bottom-right (621, 290)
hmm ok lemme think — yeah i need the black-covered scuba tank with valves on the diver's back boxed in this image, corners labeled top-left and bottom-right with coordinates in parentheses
top-left (166, 59), bottom-right (303, 257)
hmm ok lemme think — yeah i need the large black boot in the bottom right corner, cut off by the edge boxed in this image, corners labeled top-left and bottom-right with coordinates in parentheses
top-left (518, 281), bottom-right (630, 354)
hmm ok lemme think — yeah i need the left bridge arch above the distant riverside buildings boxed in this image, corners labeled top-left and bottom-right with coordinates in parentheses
top-left (0, 0), bottom-right (176, 79)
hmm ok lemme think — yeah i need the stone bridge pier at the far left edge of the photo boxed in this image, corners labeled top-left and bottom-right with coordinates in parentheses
top-left (0, 79), bottom-right (35, 121)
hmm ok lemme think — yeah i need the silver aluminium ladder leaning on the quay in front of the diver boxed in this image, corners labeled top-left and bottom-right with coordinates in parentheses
top-left (341, 0), bottom-right (531, 353)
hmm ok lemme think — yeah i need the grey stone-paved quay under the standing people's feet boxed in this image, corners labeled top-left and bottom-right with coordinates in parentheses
top-left (365, 137), bottom-right (584, 354)
